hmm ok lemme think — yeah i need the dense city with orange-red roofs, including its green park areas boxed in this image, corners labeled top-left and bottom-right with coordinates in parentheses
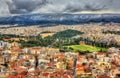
top-left (0, 24), bottom-right (120, 78)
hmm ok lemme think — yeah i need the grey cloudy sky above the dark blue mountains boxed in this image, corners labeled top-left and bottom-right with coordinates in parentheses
top-left (0, 0), bottom-right (120, 15)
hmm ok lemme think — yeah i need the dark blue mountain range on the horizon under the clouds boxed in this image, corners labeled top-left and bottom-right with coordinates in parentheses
top-left (0, 14), bottom-right (120, 26)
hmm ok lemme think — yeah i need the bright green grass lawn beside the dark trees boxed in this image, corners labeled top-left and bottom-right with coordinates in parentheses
top-left (66, 45), bottom-right (106, 52)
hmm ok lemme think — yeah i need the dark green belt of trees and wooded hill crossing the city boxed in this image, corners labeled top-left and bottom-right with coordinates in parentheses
top-left (0, 29), bottom-right (120, 48)
